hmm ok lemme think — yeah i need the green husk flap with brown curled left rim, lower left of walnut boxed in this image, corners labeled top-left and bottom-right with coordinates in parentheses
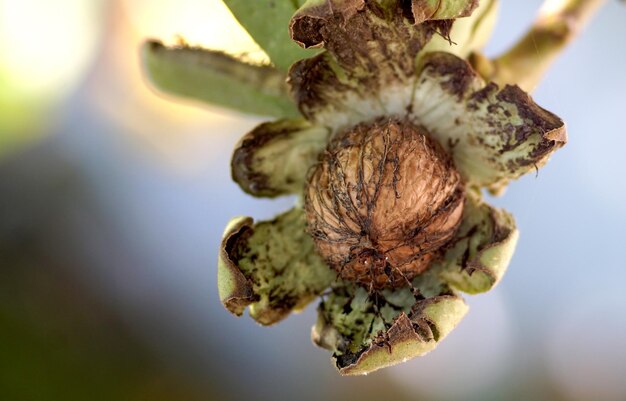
top-left (218, 208), bottom-right (335, 325)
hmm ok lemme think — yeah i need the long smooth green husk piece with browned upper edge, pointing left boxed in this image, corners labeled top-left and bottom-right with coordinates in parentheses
top-left (141, 41), bottom-right (299, 117)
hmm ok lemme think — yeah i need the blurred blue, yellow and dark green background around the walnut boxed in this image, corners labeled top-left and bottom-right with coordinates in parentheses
top-left (0, 0), bottom-right (626, 401)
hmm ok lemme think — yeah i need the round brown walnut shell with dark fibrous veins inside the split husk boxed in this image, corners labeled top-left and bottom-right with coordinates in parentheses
top-left (305, 119), bottom-right (465, 289)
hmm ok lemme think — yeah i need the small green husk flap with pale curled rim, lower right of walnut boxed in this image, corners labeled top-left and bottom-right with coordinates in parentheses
top-left (431, 191), bottom-right (519, 294)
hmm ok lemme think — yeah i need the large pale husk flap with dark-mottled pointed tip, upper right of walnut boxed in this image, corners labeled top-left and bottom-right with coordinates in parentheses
top-left (410, 53), bottom-right (567, 193)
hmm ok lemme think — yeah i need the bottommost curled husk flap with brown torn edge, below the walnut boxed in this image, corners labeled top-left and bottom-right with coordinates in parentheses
top-left (312, 274), bottom-right (468, 375)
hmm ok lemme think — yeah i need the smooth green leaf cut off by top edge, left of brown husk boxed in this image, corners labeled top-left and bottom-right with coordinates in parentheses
top-left (223, 0), bottom-right (314, 71)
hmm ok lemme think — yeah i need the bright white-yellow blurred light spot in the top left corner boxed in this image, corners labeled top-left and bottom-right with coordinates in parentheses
top-left (0, 0), bottom-right (99, 98)
